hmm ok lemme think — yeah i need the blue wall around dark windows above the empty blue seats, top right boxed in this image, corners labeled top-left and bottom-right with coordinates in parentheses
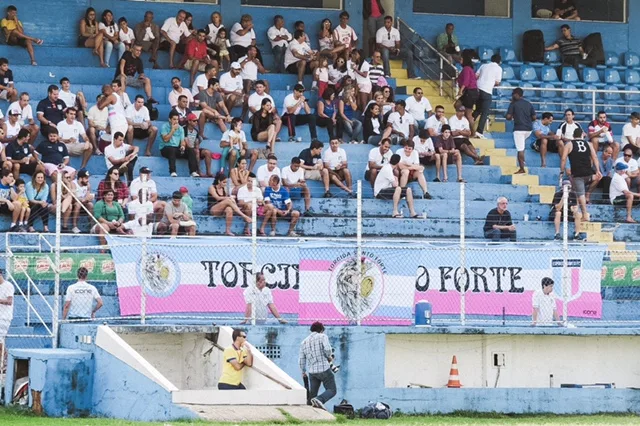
top-left (395, 0), bottom-right (640, 53)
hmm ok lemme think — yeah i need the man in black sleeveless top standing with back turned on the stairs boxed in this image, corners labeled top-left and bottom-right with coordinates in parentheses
top-left (560, 128), bottom-right (602, 222)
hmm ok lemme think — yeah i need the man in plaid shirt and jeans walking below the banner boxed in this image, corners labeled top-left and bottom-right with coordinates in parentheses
top-left (299, 321), bottom-right (336, 410)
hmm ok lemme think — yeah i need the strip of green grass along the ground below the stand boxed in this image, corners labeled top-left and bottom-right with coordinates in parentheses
top-left (0, 408), bottom-right (640, 426)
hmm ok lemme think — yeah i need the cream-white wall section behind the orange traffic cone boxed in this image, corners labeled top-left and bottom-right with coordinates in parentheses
top-left (385, 334), bottom-right (640, 388)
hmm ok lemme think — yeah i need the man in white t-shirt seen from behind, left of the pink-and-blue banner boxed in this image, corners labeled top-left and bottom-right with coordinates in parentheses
top-left (62, 266), bottom-right (103, 320)
